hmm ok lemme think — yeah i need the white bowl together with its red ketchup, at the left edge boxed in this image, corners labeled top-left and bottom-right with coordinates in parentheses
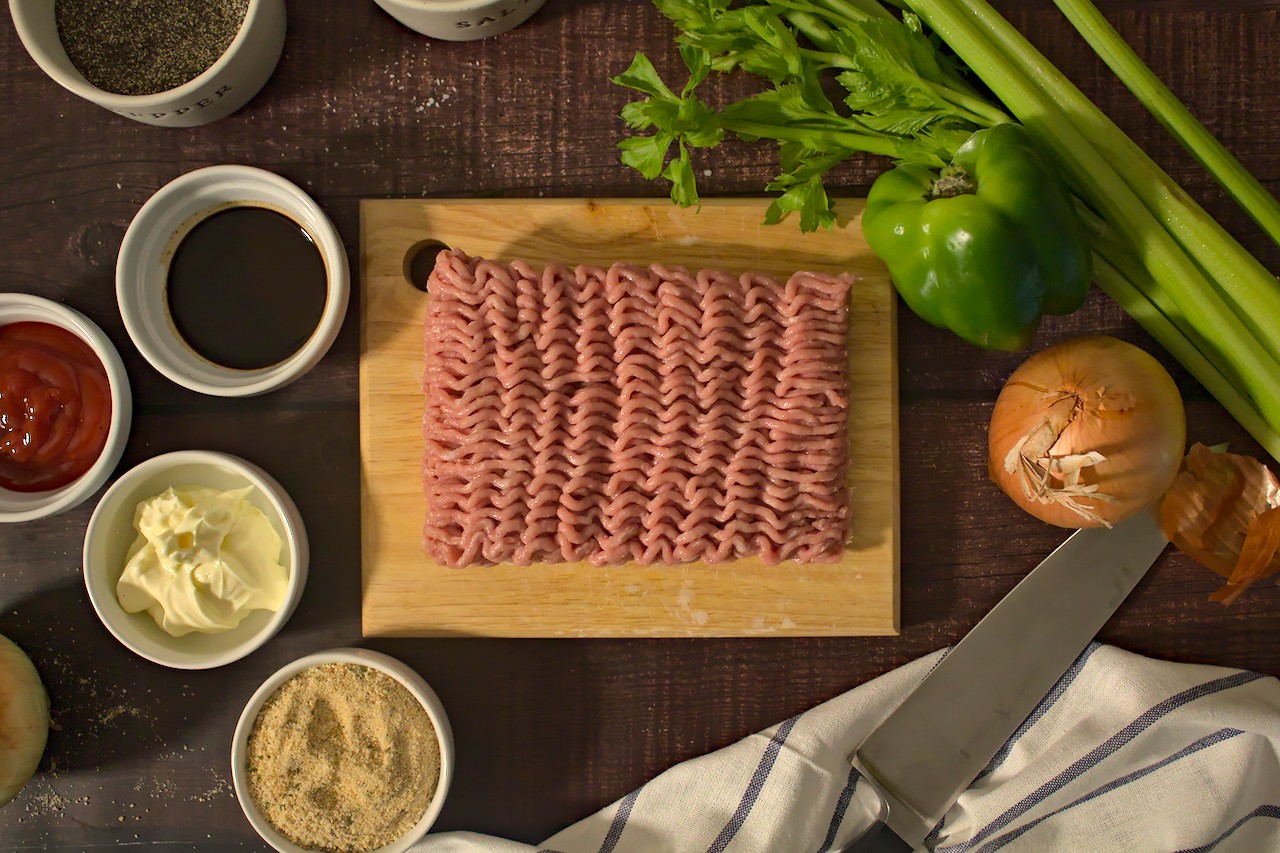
top-left (0, 293), bottom-right (133, 521)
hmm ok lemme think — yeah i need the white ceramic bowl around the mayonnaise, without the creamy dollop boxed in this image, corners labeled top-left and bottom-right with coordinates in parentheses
top-left (83, 451), bottom-right (308, 670)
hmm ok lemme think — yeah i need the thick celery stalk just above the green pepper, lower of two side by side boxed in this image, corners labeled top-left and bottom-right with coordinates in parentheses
top-left (910, 0), bottom-right (1280, 428)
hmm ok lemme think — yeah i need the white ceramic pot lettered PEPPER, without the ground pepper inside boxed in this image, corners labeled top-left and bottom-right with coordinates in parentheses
top-left (9, 0), bottom-right (285, 127)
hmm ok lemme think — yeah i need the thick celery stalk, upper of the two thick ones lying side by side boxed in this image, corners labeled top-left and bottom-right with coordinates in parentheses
top-left (911, 0), bottom-right (1280, 370)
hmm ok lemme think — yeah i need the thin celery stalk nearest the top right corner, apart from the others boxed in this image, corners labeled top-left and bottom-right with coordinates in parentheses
top-left (1053, 0), bottom-right (1280, 249)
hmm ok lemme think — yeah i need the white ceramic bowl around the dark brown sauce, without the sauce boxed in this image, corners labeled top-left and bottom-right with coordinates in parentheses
top-left (115, 165), bottom-right (351, 397)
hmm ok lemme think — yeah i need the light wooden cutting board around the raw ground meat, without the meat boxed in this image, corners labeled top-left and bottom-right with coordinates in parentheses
top-left (360, 199), bottom-right (899, 637)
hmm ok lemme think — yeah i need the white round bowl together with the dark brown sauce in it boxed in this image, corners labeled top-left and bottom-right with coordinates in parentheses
top-left (115, 165), bottom-right (351, 397)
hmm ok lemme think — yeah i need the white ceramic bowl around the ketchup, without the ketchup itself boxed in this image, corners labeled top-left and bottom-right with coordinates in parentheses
top-left (0, 293), bottom-right (133, 521)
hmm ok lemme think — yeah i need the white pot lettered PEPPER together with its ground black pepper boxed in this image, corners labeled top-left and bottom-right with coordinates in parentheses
top-left (9, 0), bottom-right (285, 127)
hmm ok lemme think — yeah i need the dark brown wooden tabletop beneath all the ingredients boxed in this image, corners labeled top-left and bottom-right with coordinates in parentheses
top-left (0, 0), bottom-right (1280, 849)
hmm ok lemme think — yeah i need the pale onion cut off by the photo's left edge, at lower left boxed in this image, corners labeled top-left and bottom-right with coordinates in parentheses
top-left (0, 637), bottom-right (49, 807)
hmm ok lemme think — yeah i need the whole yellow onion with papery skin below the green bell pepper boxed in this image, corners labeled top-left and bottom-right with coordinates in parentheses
top-left (987, 336), bottom-right (1187, 528)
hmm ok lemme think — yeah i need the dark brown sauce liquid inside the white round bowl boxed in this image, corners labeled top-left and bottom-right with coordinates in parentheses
top-left (166, 206), bottom-right (328, 370)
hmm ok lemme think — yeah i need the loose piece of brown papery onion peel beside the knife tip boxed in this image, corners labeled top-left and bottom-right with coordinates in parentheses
top-left (1160, 444), bottom-right (1280, 605)
